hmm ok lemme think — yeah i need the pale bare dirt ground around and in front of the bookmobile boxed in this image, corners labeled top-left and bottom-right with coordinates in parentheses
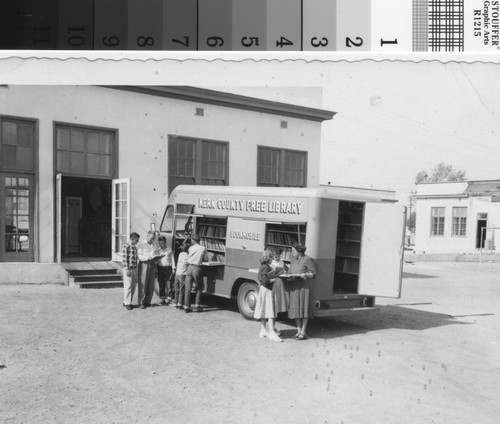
top-left (0, 263), bottom-right (500, 424)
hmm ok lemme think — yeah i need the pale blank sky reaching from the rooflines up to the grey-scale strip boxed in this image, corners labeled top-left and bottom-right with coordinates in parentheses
top-left (0, 52), bottom-right (500, 209)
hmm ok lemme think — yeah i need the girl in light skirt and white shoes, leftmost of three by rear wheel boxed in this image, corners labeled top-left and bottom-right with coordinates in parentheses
top-left (254, 250), bottom-right (283, 342)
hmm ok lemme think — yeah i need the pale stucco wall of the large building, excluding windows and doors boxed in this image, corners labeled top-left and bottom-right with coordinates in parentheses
top-left (0, 86), bottom-right (321, 263)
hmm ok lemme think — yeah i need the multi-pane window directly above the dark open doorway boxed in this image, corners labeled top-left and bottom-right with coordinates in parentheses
top-left (56, 126), bottom-right (116, 178)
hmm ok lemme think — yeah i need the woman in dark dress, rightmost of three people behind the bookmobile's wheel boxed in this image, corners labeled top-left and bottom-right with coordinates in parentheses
top-left (288, 244), bottom-right (316, 340)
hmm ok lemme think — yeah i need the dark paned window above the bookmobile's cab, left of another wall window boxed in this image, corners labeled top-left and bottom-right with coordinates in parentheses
top-left (168, 136), bottom-right (229, 192)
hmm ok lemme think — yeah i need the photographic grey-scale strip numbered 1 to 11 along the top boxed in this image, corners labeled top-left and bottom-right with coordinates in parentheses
top-left (0, 0), bottom-right (500, 53)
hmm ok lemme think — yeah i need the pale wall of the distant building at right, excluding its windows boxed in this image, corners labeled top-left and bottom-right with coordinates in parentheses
top-left (415, 196), bottom-right (500, 253)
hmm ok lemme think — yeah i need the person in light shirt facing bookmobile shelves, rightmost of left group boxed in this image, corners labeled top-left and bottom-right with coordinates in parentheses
top-left (184, 234), bottom-right (207, 312)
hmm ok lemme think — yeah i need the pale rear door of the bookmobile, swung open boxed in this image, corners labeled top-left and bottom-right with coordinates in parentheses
top-left (358, 203), bottom-right (406, 298)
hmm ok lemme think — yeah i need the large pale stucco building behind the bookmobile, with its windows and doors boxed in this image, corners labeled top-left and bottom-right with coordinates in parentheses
top-left (0, 86), bottom-right (334, 282)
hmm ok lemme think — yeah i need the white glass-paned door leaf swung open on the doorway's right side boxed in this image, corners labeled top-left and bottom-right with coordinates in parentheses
top-left (111, 178), bottom-right (130, 262)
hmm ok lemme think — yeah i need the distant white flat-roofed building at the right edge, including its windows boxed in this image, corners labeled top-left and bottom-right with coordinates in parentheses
top-left (415, 180), bottom-right (500, 253)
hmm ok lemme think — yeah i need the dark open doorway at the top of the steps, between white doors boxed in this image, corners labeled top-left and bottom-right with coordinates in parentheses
top-left (60, 176), bottom-right (111, 262)
